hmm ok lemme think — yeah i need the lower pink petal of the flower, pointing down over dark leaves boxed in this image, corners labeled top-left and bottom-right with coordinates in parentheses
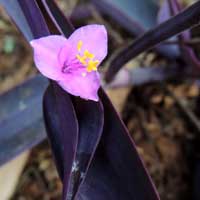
top-left (58, 70), bottom-right (100, 101)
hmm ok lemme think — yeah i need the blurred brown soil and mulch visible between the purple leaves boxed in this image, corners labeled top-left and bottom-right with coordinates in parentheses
top-left (0, 1), bottom-right (200, 200)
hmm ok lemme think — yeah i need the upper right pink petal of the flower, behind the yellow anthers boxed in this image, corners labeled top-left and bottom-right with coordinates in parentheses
top-left (68, 24), bottom-right (108, 63)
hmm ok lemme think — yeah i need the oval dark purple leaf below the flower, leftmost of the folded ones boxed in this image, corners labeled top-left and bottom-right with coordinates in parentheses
top-left (43, 82), bottom-right (78, 184)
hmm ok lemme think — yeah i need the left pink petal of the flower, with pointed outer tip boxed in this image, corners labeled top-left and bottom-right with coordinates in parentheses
top-left (30, 35), bottom-right (70, 80)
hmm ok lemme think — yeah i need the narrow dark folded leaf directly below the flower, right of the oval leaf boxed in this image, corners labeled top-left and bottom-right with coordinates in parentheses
top-left (64, 98), bottom-right (104, 199)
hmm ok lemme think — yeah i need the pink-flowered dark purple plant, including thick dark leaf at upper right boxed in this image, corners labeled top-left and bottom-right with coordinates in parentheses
top-left (0, 0), bottom-right (200, 200)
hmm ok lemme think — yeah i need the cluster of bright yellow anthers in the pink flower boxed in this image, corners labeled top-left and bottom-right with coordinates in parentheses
top-left (76, 40), bottom-right (99, 76)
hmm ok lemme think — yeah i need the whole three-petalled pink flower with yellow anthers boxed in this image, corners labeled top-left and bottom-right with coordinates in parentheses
top-left (30, 25), bottom-right (107, 101)
